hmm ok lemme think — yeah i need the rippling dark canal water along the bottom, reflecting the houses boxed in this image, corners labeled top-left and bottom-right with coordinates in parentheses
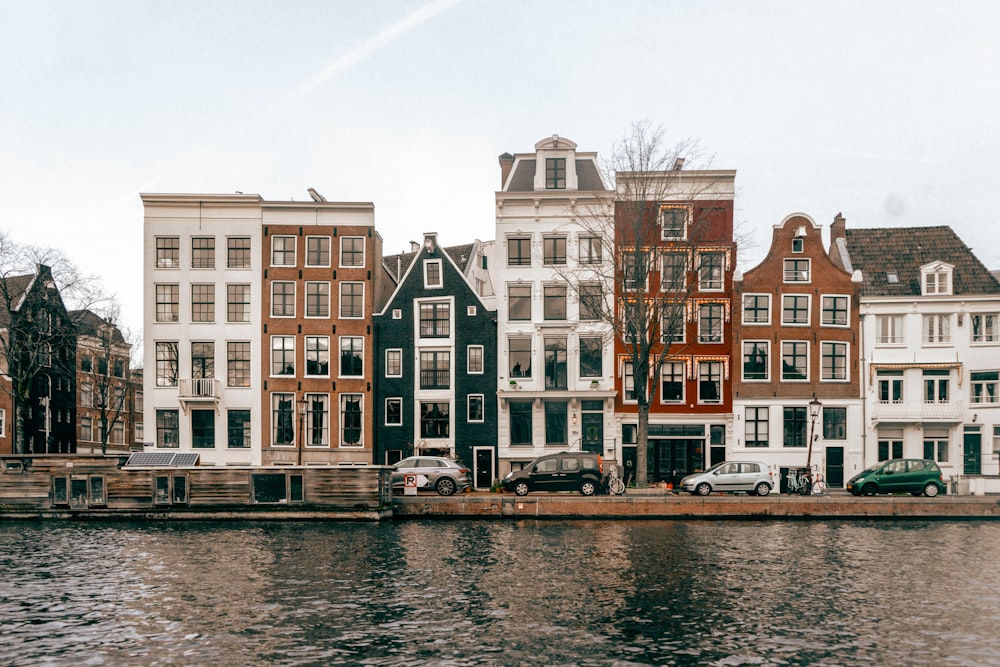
top-left (0, 520), bottom-right (1000, 667)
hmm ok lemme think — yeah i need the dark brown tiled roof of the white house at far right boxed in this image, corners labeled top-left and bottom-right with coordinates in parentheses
top-left (846, 226), bottom-right (1000, 296)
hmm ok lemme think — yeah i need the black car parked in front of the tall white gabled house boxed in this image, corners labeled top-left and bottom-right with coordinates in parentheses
top-left (503, 452), bottom-right (604, 496)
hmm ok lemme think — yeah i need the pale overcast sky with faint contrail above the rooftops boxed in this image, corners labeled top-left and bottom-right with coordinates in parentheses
top-left (0, 0), bottom-right (1000, 329)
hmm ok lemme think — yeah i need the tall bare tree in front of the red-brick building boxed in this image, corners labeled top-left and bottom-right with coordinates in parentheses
top-left (567, 122), bottom-right (735, 484)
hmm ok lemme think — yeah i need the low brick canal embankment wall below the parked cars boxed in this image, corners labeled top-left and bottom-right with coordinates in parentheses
top-left (393, 493), bottom-right (1000, 519)
